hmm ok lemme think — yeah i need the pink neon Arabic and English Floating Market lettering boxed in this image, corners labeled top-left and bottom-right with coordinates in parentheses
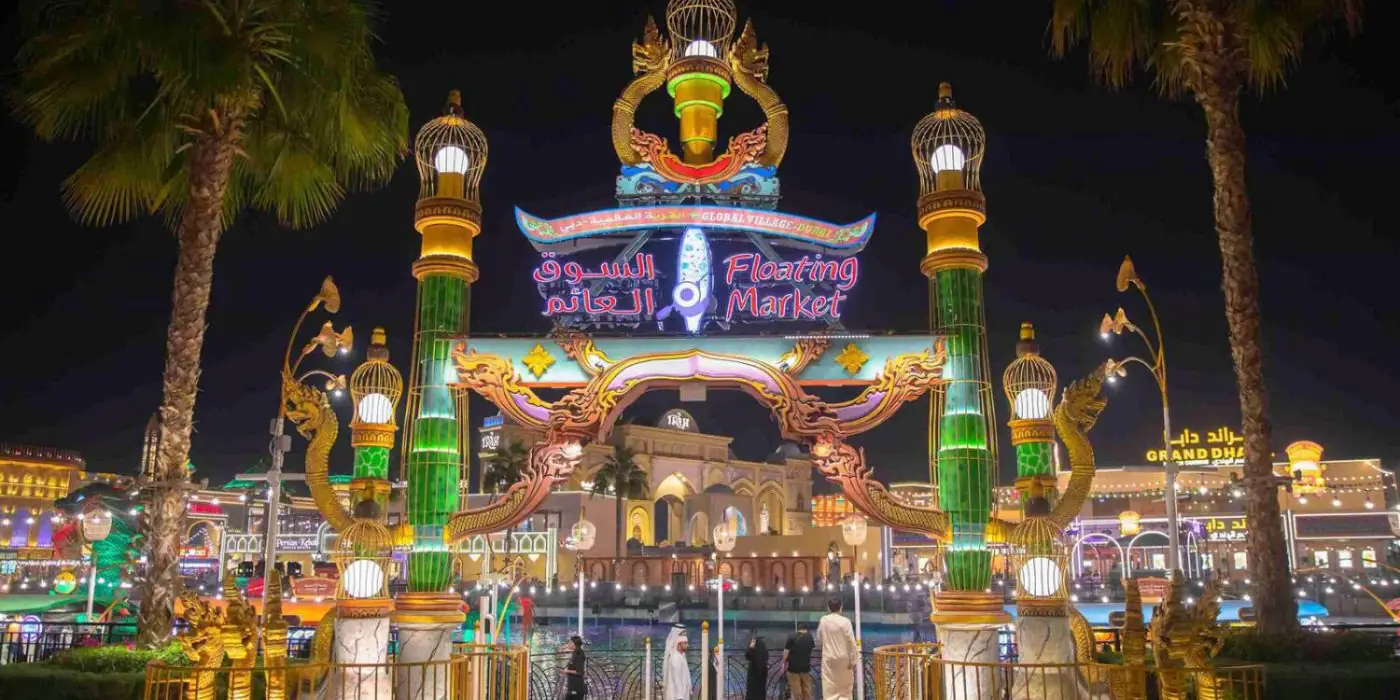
top-left (532, 253), bottom-right (860, 322)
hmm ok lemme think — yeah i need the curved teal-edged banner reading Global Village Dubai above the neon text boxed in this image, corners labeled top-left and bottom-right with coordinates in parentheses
top-left (515, 206), bottom-right (875, 255)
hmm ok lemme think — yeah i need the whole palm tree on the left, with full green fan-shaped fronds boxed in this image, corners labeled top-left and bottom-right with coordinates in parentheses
top-left (11, 0), bottom-right (407, 645)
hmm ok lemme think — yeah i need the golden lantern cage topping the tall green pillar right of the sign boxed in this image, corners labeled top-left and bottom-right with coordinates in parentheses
top-left (910, 83), bottom-right (987, 203)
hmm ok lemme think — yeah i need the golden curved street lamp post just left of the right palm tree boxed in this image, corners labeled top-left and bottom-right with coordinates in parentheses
top-left (1099, 256), bottom-right (1182, 575)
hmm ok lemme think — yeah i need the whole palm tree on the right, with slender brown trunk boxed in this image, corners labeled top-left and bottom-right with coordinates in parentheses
top-left (1050, 0), bottom-right (1361, 633)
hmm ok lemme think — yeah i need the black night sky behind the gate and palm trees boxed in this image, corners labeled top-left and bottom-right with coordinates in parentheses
top-left (0, 0), bottom-right (1400, 483)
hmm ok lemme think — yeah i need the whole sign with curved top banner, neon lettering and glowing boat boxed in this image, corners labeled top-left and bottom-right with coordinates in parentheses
top-left (517, 206), bottom-right (875, 333)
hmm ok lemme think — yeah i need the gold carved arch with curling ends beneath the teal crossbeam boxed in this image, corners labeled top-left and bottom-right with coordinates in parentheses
top-left (445, 340), bottom-right (946, 542)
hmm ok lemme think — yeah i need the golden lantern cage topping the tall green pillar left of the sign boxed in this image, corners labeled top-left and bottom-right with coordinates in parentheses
top-left (413, 90), bottom-right (486, 205)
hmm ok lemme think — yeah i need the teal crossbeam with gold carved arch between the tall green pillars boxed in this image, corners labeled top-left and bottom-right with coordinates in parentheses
top-left (444, 335), bottom-right (945, 542)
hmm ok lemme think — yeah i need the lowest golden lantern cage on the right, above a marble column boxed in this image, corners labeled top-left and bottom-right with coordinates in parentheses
top-left (1007, 515), bottom-right (1070, 615)
